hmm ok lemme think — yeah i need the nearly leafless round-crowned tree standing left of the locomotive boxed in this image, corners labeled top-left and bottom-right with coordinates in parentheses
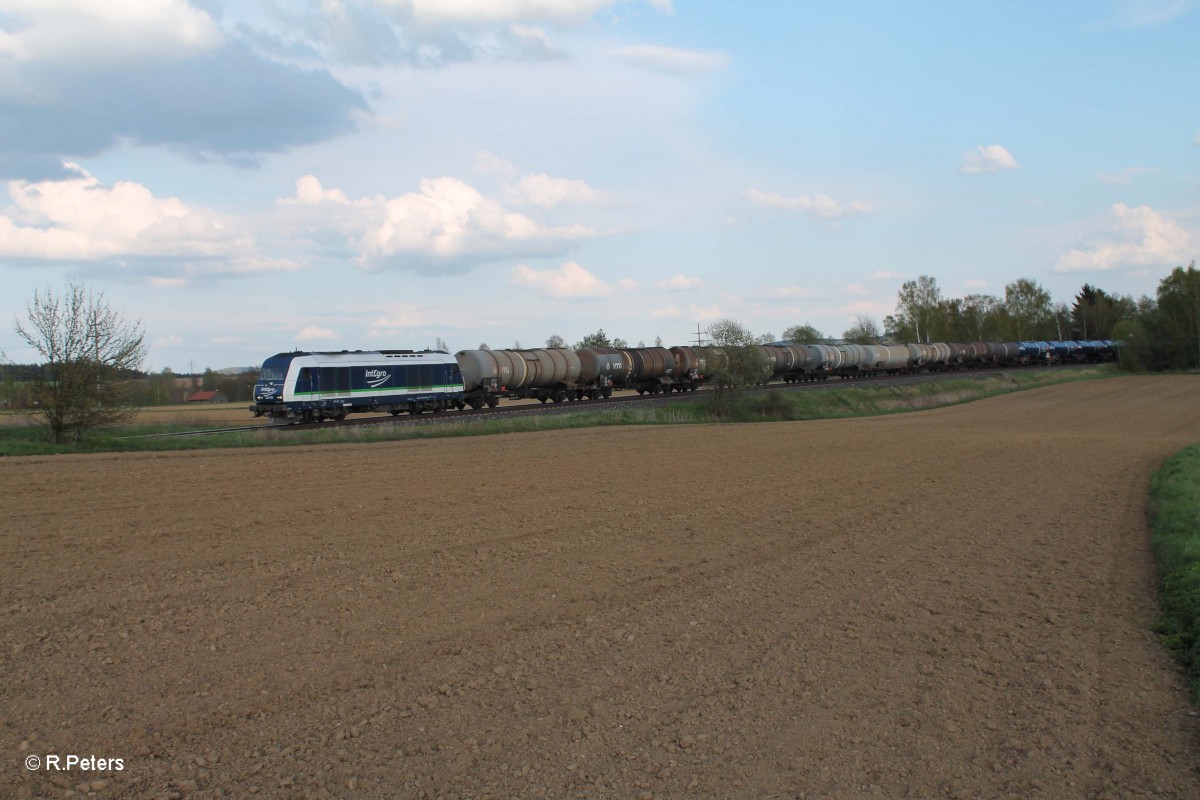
top-left (16, 282), bottom-right (146, 443)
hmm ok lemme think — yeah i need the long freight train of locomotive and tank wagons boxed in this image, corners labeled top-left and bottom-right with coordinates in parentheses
top-left (250, 339), bottom-right (1118, 422)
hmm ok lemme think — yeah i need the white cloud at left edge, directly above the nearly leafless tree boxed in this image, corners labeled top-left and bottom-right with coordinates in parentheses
top-left (0, 163), bottom-right (299, 280)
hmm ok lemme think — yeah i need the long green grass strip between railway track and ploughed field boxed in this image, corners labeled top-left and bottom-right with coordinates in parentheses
top-left (0, 367), bottom-right (1117, 456)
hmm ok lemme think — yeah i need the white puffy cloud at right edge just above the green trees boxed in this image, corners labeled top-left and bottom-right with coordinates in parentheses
top-left (1055, 203), bottom-right (1195, 272)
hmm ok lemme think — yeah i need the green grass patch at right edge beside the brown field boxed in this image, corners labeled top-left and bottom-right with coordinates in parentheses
top-left (1147, 444), bottom-right (1200, 705)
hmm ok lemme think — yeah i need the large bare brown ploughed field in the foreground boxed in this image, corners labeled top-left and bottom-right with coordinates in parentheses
top-left (0, 377), bottom-right (1200, 799)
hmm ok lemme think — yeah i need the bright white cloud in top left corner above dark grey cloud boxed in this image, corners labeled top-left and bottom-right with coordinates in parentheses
top-left (0, 0), bottom-right (223, 66)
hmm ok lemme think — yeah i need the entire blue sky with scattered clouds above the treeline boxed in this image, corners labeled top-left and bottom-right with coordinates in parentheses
top-left (0, 0), bottom-right (1200, 372)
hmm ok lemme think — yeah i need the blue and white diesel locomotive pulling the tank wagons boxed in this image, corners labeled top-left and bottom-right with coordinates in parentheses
top-left (250, 350), bottom-right (464, 422)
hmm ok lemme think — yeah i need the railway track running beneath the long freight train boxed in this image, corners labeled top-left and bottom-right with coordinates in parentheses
top-left (145, 365), bottom-right (1094, 439)
